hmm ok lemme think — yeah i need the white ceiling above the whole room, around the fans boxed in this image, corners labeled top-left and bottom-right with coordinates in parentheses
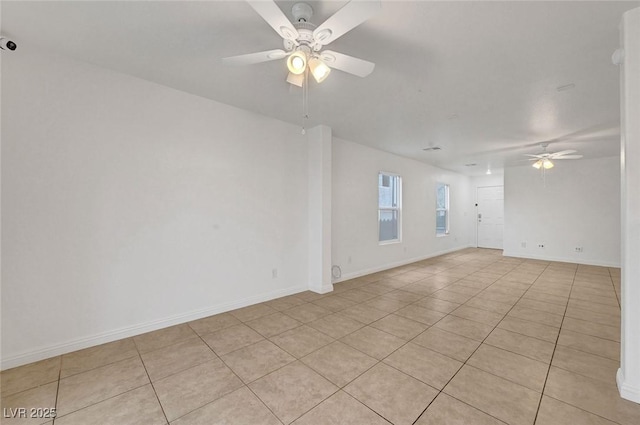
top-left (2, 1), bottom-right (640, 175)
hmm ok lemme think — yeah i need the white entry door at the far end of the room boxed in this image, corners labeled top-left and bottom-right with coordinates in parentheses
top-left (476, 186), bottom-right (504, 249)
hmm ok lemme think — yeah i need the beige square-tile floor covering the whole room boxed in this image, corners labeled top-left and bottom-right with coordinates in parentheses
top-left (1, 249), bottom-right (640, 425)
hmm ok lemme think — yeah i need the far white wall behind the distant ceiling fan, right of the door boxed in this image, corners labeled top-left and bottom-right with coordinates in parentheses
top-left (504, 157), bottom-right (620, 267)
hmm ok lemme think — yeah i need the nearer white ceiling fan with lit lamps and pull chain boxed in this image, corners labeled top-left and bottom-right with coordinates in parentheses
top-left (223, 0), bottom-right (381, 87)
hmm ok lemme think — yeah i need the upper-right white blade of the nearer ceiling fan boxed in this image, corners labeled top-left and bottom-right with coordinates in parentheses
top-left (313, 0), bottom-right (381, 46)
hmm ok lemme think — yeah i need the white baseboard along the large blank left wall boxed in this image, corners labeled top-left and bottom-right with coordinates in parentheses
top-left (0, 285), bottom-right (310, 370)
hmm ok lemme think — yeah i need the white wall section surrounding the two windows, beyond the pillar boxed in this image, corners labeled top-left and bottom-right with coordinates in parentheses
top-left (331, 137), bottom-right (473, 280)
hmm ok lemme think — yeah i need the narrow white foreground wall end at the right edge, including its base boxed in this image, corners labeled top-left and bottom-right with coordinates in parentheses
top-left (617, 8), bottom-right (640, 403)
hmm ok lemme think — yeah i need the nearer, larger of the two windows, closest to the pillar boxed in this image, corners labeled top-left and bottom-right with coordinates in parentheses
top-left (378, 173), bottom-right (402, 243)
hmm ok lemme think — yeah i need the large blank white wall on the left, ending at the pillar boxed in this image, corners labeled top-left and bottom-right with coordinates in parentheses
top-left (2, 49), bottom-right (307, 368)
